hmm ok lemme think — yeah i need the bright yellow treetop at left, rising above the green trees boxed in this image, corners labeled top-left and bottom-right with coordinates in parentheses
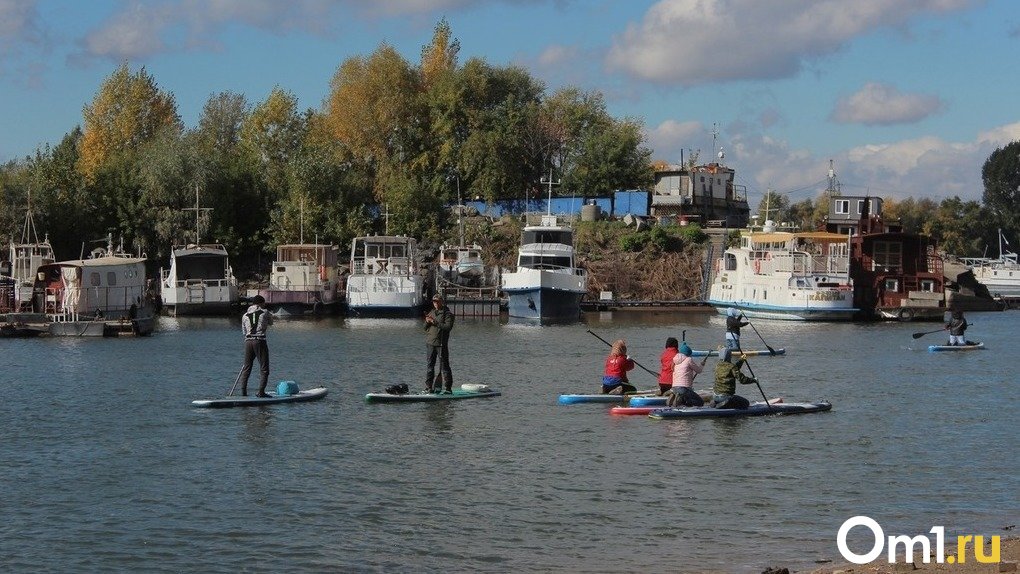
top-left (79, 63), bottom-right (184, 181)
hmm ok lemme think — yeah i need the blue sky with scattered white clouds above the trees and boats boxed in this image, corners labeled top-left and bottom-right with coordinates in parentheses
top-left (0, 0), bottom-right (1020, 211)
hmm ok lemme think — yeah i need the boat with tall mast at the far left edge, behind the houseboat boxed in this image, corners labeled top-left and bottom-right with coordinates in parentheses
top-left (0, 200), bottom-right (56, 313)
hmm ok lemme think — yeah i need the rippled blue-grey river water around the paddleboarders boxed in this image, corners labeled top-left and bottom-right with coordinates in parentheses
top-left (0, 311), bottom-right (1020, 572)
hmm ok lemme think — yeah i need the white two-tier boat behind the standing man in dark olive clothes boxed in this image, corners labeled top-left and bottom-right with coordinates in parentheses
top-left (346, 236), bottom-right (425, 317)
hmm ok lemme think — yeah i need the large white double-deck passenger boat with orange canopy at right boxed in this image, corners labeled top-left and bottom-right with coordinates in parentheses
top-left (708, 221), bottom-right (858, 321)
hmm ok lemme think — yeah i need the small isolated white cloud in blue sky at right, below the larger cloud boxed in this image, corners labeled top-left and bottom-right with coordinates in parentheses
top-left (830, 83), bottom-right (944, 125)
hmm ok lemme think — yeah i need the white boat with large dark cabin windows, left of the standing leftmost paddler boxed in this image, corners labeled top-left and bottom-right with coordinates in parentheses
top-left (159, 244), bottom-right (239, 315)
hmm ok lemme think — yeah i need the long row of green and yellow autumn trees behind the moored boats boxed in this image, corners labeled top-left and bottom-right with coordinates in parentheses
top-left (0, 20), bottom-right (653, 273)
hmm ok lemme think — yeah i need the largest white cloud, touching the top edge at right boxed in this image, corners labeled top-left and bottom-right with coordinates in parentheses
top-left (606, 0), bottom-right (974, 86)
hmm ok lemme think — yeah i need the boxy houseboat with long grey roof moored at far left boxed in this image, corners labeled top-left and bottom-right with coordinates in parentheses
top-left (33, 238), bottom-right (156, 336)
